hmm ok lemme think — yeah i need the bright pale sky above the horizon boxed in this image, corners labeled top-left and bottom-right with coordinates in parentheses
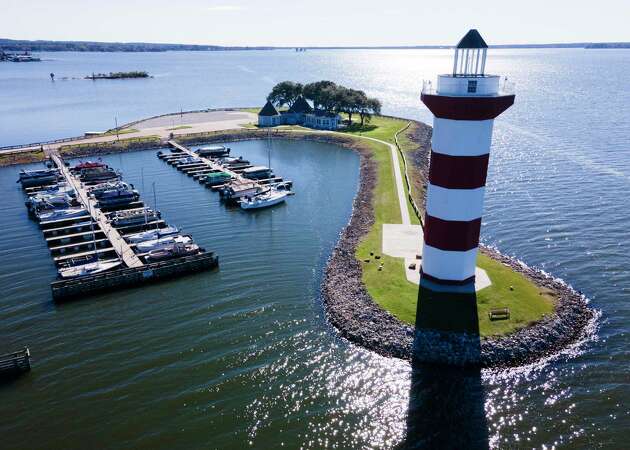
top-left (0, 0), bottom-right (630, 46)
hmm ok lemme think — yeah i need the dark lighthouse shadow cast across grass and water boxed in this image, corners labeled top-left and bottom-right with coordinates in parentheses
top-left (399, 287), bottom-right (489, 449)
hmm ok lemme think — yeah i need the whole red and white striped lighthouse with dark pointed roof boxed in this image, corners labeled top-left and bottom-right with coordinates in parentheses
top-left (421, 30), bottom-right (514, 286)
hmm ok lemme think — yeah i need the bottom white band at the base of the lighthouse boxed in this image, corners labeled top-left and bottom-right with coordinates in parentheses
top-left (422, 243), bottom-right (477, 281)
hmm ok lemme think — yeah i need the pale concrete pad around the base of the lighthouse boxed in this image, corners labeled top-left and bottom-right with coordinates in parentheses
top-left (382, 223), bottom-right (492, 292)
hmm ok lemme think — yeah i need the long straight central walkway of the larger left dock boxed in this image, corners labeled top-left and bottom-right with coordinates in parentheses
top-left (49, 151), bottom-right (144, 268)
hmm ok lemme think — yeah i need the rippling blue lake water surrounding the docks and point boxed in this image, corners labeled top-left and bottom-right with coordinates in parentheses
top-left (0, 49), bottom-right (630, 448)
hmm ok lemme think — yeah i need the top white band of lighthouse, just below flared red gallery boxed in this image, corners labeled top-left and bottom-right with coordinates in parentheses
top-left (431, 117), bottom-right (494, 156)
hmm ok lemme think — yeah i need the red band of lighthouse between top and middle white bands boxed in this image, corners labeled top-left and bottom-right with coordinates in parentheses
top-left (429, 151), bottom-right (490, 189)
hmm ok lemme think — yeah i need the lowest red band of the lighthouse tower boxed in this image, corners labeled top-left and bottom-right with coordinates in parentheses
top-left (424, 214), bottom-right (481, 252)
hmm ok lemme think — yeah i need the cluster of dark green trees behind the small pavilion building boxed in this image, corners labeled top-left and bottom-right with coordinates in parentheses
top-left (267, 80), bottom-right (381, 125)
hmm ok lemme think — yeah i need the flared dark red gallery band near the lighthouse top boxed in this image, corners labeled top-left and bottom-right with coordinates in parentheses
top-left (421, 94), bottom-right (514, 120)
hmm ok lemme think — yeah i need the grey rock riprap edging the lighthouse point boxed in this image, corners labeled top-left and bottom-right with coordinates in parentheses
top-left (322, 120), bottom-right (594, 368)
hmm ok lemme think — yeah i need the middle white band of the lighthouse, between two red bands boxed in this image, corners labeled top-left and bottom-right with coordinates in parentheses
top-left (426, 183), bottom-right (485, 222)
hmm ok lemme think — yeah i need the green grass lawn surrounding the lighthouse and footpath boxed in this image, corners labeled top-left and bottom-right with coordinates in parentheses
top-left (345, 117), bottom-right (555, 336)
